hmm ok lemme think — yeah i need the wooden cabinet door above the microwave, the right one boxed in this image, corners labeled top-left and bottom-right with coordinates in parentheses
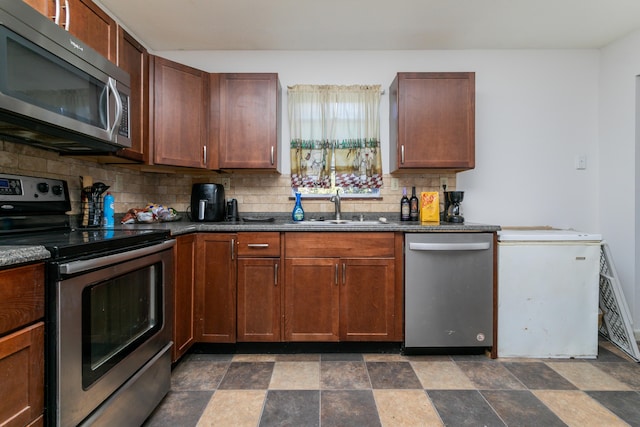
top-left (67, 0), bottom-right (117, 63)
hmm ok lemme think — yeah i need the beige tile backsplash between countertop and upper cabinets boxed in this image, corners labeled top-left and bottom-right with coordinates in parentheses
top-left (0, 140), bottom-right (456, 219)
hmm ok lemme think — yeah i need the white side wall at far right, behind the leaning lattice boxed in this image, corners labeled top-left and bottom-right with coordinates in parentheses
top-left (599, 31), bottom-right (640, 334)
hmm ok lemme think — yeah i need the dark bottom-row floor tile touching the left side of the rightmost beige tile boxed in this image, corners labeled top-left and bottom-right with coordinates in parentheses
top-left (480, 390), bottom-right (565, 427)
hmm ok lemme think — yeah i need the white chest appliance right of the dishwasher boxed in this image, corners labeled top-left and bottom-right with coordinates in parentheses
top-left (498, 229), bottom-right (602, 358)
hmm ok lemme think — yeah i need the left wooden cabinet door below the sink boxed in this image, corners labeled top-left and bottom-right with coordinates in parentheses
top-left (284, 258), bottom-right (340, 341)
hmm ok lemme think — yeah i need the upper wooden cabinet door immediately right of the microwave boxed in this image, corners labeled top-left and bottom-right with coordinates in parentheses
top-left (118, 27), bottom-right (149, 163)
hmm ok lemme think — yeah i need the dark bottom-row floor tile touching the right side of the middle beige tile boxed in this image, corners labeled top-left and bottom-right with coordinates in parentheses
top-left (427, 390), bottom-right (505, 427)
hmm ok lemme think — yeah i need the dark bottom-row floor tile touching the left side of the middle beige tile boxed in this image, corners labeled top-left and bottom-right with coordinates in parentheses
top-left (320, 390), bottom-right (381, 427)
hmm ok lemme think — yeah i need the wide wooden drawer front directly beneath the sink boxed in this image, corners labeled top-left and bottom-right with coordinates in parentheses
top-left (285, 232), bottom-right (395, 258)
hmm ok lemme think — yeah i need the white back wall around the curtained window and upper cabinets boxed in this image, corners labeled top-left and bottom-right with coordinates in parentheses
top-left (157, 50), bottom-right (600, 232)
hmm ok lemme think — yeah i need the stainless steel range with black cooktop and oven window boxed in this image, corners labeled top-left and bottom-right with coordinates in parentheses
top-left (0, 174), bottom-right (175, 426)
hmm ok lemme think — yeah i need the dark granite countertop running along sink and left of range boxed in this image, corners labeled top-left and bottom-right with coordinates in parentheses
top-left (0, 213), bottom-right (500, 267)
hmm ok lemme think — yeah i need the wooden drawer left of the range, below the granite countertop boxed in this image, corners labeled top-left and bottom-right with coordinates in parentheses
top-left (0, 264), bottom-right (44, 334)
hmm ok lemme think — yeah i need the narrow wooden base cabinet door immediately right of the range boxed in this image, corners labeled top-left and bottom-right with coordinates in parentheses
top-left (172, 234), bottom-right (196, 362)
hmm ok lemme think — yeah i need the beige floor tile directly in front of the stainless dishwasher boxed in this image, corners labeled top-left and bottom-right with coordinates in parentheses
top-left (411, 361), bottom-right (475, 390)
